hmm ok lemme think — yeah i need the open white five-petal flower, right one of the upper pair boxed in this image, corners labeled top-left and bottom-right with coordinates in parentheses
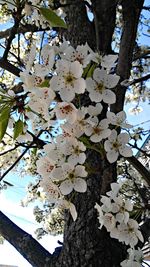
top-left (86, 68), bottom-right (119, 104)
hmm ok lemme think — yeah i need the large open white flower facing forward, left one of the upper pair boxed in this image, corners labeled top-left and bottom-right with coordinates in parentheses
top-left (50, 60), bottom-right (86, 102)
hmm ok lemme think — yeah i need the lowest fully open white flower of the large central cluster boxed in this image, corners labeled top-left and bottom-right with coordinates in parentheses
top-left (52, 163), bottom-right (87, 195)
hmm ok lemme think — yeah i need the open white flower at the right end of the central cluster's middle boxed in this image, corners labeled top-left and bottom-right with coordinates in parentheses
top-left (104, 130), bottom-right (132, 163)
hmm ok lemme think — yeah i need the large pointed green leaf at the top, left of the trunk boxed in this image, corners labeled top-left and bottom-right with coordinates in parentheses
top-left (39, 7), bottom-right (67, 29)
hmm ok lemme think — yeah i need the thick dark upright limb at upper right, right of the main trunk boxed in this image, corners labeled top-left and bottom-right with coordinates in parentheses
top-left (111, 0), bottom-right (144, 113)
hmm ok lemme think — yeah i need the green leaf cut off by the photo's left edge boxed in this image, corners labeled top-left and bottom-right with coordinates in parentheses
top-left (0, 106), bottom-right (11, 142)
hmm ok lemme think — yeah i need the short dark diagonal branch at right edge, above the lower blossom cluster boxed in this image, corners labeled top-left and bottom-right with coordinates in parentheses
top-left (127, 156), bottom-right (150, 186)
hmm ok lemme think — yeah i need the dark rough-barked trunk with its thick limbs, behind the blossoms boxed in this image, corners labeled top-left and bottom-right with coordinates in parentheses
top-left (0, 0), bottom-right (149, 267)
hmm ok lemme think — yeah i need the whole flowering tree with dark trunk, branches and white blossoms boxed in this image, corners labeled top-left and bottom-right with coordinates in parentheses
top-left (0, 0), bottom-right (150, 267)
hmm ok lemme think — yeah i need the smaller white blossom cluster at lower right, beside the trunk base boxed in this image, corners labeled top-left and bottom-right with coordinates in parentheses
top-left (95, 183), bottom-right (144, 267)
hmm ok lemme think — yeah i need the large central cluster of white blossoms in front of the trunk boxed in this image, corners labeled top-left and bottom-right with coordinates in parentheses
top-left (17, 40), bottom-right (132, 222)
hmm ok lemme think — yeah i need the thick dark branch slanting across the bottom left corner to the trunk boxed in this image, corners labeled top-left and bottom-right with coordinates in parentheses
top-left (0, 211), bottom-right (52, 267)
